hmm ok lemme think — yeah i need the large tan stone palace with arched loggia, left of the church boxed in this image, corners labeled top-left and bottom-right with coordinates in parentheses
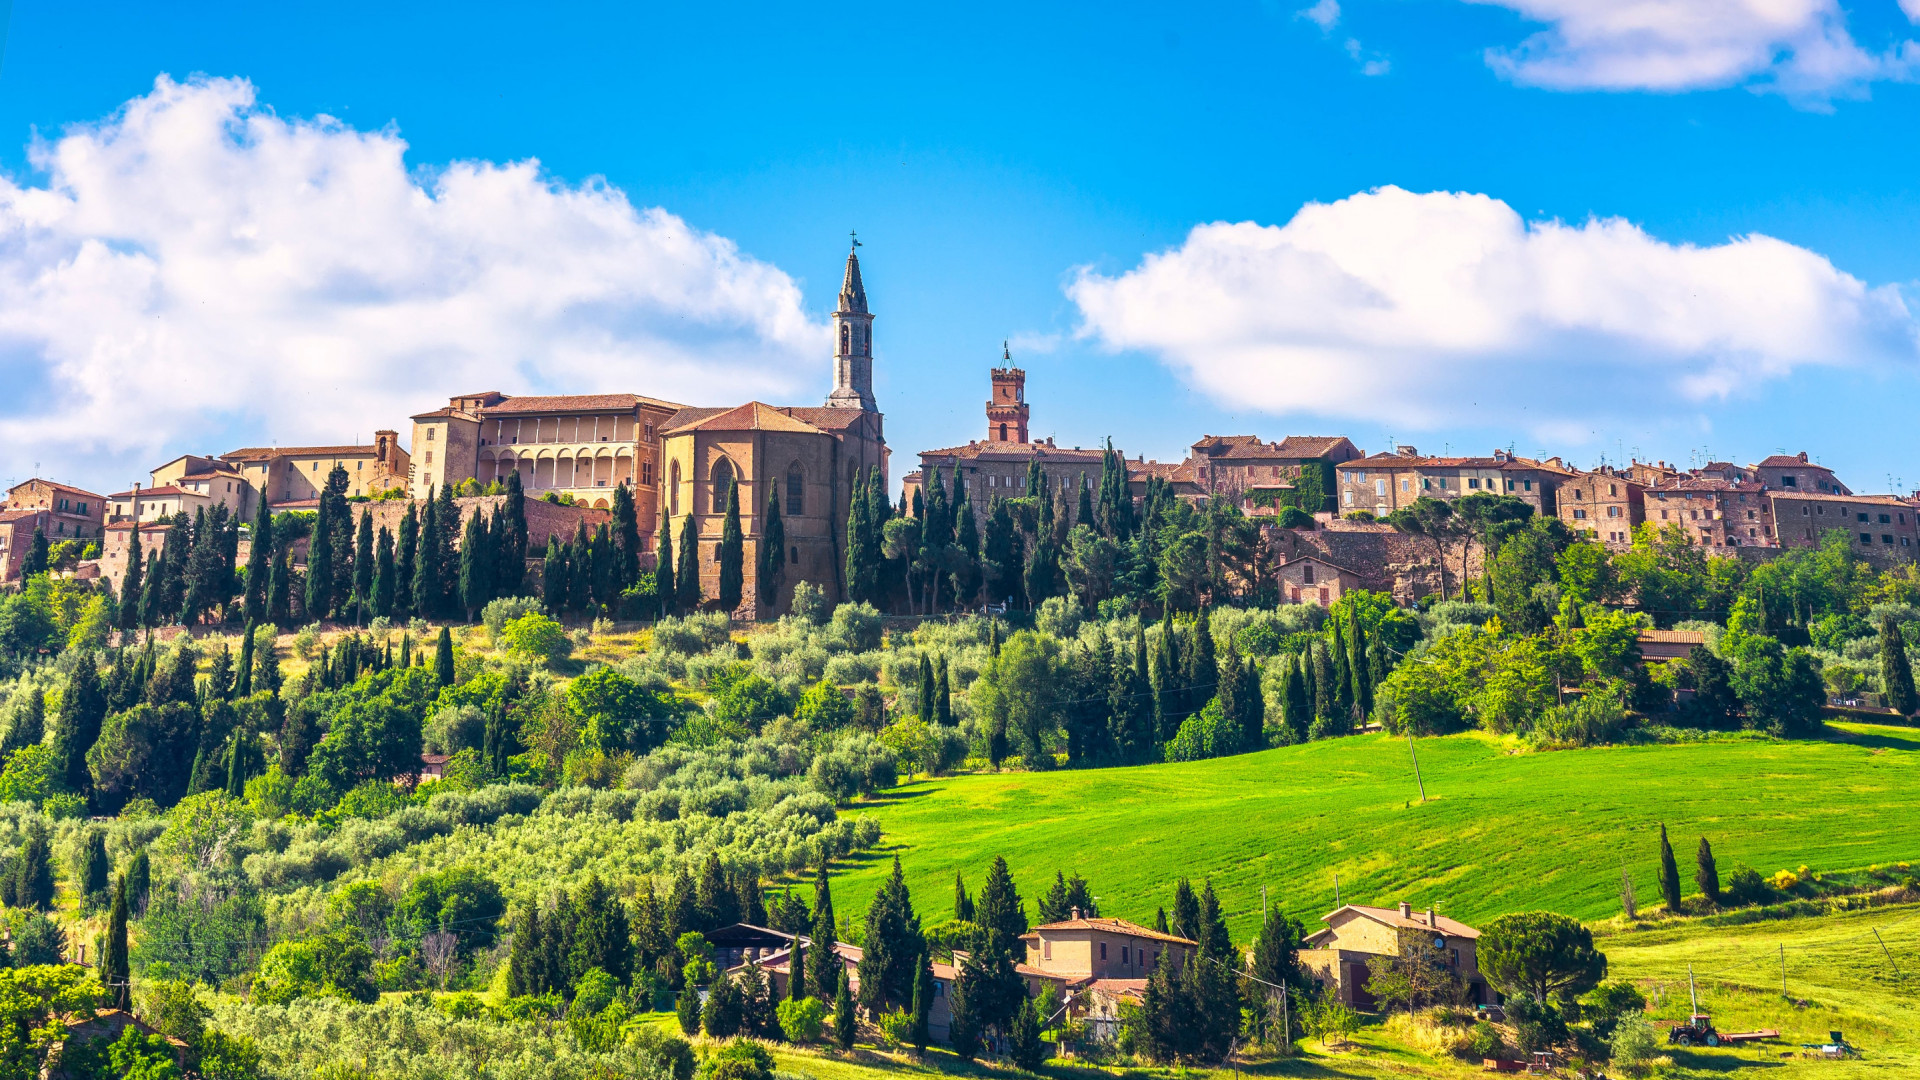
top-left (409, 390), bottom-right (685, 526)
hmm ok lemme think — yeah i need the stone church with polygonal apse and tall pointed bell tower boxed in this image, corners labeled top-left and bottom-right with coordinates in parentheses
top-left (655, 242), bottom-right (889, 619)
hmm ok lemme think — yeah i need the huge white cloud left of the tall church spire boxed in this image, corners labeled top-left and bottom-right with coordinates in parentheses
top-left (0, 77), bottom-right (828, 490)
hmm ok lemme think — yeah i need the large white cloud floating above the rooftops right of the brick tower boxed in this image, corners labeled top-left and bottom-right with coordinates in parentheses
top-left (1068, 186), bottom-right (1920, 434)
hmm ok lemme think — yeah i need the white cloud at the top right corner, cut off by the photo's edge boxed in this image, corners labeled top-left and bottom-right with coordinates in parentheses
top-left (1469, 0), bottom-right (1920, 102)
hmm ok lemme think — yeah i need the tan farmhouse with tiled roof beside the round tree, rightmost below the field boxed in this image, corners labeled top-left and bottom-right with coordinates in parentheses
top-left (1300, 903), bottom-right (1494, 1009)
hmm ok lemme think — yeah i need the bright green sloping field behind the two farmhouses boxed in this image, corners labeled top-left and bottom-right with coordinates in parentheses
top-left (835, 724), bottom-right (1920, 937)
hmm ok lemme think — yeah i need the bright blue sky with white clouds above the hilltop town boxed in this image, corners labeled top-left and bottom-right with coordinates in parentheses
top-left (0, 0), bottom-right (1920, 490)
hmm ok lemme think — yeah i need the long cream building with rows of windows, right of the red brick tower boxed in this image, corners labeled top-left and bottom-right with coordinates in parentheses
top-left (1334, 446), bottom-right (1572, 517)
